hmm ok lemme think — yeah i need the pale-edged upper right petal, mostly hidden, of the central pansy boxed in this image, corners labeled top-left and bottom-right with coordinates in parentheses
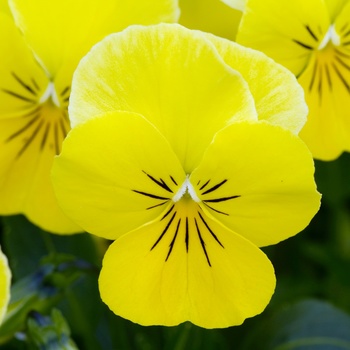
top-left (207, 34), bottom-right (308, 134)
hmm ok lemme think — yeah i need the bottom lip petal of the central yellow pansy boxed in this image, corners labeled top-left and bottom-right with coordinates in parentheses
top-left (99, 200), bottom-right (275, 328)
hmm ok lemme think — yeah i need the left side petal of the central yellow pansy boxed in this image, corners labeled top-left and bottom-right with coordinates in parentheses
top-left (52, 112), bottom-right (186, 239)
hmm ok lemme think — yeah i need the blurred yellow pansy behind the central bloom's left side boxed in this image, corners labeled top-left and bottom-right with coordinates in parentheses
top-left (0, 0), bottom-right (178, 233)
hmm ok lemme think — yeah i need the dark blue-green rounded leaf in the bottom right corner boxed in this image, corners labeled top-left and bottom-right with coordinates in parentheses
top-left (245, 300), bottom-right (350, 350)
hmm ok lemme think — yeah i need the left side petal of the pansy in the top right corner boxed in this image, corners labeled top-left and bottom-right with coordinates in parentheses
top-left (237, 0), bottom-right (330, 75)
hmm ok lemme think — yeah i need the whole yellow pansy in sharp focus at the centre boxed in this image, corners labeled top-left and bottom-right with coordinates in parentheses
top-left (53, 24), bottom-right (320, 328)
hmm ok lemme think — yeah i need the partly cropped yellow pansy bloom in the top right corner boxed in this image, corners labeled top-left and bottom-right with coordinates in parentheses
top-left (237, 0), bottom-right (350, 160)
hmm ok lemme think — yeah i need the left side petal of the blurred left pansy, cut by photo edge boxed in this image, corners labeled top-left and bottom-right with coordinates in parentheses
top-left (0, 13), bottom-right (48, 119)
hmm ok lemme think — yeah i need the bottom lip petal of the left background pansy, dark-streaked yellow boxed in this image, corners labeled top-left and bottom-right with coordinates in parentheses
top-left (0, 105), bottom-right (81, 233)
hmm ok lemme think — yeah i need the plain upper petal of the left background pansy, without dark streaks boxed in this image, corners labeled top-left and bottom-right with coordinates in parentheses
top-left (10, 0), bottom-right (178, 79)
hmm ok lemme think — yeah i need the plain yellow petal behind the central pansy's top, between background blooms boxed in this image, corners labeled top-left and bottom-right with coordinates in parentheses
top-left (179, 0), bottom-right (242, 40)
